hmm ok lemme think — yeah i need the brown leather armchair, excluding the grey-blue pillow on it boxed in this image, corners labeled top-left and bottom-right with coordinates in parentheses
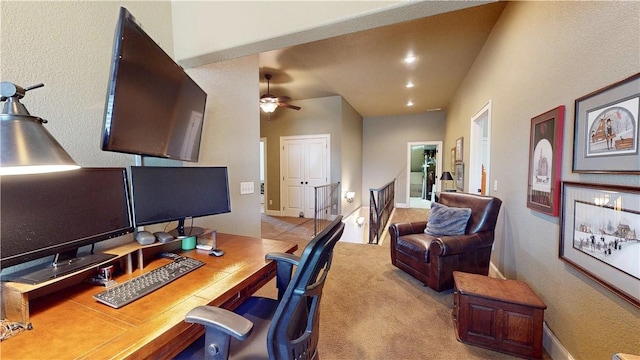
top-left (389, 192), bottom-right (502, 291)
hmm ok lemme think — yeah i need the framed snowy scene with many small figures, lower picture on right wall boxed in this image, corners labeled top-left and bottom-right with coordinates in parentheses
top-left (560, 182), bottom-right (640, 307)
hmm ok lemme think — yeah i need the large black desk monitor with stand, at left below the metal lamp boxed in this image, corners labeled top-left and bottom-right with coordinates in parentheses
top-left (0, 168), bottom-right (133, 284)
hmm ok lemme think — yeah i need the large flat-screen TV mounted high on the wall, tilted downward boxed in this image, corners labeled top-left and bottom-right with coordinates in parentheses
top-left (102, 8), bottom-right (207, 162)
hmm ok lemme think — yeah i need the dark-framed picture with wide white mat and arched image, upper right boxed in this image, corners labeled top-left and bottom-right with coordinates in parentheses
top-left (573, 73), bottom-right (640, 174)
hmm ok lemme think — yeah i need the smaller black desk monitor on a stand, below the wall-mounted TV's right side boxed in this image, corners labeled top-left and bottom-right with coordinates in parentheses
top-left (131, 166), bottom-right (231, 238)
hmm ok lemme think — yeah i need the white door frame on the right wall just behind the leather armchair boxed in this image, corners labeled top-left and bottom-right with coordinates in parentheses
top-left (467, 100), bottom-right (492, 195)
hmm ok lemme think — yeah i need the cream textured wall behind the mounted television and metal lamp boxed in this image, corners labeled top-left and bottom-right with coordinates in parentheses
top-left (0, 1), bottom-right (173, 255)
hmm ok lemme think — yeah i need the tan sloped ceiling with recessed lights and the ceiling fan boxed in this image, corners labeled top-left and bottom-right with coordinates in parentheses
top-left (259, 2), bottom-right (505, 117)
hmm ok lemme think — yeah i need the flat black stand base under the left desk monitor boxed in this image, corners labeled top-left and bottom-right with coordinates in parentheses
top-left (2, 253), bottom-right (117, 285)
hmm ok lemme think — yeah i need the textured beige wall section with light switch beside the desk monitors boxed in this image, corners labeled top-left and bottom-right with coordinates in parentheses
top-left (187, 55), bottom-right (261, 237)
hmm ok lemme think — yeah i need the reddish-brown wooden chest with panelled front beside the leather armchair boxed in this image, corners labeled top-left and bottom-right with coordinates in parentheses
top-left (452, 271), bottom-right (547, 359)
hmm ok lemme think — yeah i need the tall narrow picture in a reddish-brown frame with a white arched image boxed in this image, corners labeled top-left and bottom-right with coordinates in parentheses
top-left (527, 106), bottom-right (564, 216)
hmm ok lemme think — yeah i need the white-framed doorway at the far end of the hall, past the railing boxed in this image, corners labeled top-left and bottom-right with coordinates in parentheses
top-left (406, 141), bottom-right (442, 209)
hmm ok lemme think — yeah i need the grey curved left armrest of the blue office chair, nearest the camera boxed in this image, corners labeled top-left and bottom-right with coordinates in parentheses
top-left (184, 306), bottom-right (253, 341)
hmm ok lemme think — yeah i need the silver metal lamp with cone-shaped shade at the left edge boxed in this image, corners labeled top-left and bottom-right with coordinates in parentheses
top-left (0, 82), bottom-right (79, 175)
